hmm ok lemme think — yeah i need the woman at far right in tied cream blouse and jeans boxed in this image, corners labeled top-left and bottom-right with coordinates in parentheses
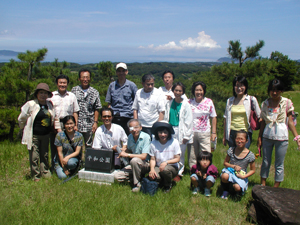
top-left (257, 79), bottom-right (300, 187)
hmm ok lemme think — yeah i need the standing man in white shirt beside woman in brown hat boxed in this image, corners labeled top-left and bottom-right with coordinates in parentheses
top-left (49, 74), bottom-right (79, 170)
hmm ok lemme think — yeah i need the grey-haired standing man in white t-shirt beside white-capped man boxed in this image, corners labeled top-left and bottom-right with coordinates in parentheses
top-left (132, 74), bottom-right (165, 136)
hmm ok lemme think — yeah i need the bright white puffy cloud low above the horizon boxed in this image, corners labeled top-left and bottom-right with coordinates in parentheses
top-left (139, 31), bottom-right (221, 51)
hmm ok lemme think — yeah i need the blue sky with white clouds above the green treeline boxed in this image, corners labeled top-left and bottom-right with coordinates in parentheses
top-left (0, 0), bottom-right (300, 63)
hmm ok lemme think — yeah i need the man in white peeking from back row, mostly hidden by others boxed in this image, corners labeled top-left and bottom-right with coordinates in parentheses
top-left (158, 70), bottom-right (188, 104)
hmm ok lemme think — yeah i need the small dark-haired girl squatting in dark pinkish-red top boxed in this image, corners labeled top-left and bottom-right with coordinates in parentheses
top-left (191, 151), bottom-right (218, 197)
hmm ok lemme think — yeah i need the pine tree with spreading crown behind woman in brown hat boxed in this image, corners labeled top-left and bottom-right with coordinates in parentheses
top-left (18, 48), bottom-right (48, 101)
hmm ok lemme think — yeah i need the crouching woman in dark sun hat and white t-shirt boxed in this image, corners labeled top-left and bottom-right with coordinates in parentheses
top-left (149, 121), bottom-right (181, 192)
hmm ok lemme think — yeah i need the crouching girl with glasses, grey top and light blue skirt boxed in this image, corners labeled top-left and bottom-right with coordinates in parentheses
top-left (221, 130), bottom-right (255, 199)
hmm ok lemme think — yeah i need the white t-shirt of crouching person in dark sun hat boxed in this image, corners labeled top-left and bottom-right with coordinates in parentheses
top-left (149, 138), bottom-right (181, 166)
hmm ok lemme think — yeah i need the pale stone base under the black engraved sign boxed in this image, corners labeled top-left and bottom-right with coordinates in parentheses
top-left (78, 169), bottom-right (116, 185)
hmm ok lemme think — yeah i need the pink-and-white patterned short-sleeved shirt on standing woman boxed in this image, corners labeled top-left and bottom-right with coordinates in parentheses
top-left (189, 97), bottom-right (217, 133)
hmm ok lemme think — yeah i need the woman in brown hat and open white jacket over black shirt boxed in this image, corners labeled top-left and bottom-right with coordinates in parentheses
top-left (18, 83), bottom-right (55, 181)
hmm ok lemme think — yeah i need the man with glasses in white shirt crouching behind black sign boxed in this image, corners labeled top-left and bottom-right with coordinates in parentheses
top-left (92, 108), bottom-right (128, 166)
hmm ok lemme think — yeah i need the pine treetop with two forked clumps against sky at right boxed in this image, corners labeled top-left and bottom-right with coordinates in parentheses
top-left (227, 40), bottom-right (265, 67)
